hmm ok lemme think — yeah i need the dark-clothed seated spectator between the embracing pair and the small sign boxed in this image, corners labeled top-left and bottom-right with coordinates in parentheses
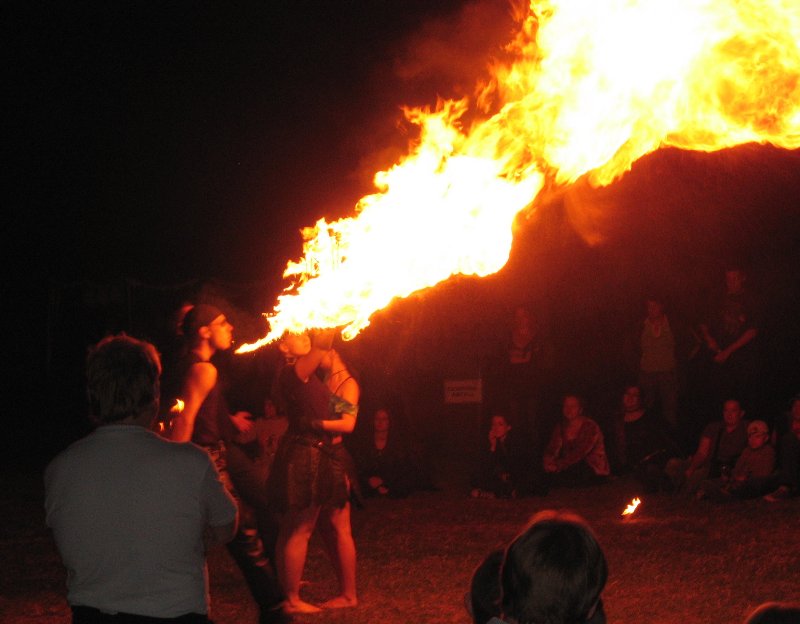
top-left (353, 408), bottom-right (422, 498)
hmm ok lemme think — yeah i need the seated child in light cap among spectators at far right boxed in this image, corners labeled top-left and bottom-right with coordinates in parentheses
top-left (696, 420), bottom-right (775, 501)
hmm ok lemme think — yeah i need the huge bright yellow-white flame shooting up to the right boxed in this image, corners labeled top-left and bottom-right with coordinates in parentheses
top-left (238, 0), bottom-right (800, 352)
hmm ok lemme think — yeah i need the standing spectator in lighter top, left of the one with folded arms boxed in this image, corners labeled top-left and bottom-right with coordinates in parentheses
top-left (639, 297), bottom-right (678, 429)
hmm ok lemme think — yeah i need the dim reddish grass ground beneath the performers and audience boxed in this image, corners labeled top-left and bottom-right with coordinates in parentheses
top-left (0, 466), bottom-right (800, 624)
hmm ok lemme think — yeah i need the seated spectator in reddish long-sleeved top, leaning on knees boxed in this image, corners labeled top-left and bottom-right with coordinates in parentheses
top-left (542, 394), bottom-right (611, 487)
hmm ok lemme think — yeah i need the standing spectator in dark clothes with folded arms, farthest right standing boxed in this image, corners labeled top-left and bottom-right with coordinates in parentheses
top-left (700, 265), bottom-right (760, 410)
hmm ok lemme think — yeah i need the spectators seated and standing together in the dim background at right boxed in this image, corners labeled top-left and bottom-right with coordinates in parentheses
top-left (471, 266), bottom-right (800, 501)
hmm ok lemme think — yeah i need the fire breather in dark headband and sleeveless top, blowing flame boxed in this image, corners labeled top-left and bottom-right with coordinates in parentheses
top-left (170, 303), bottom-right (291, 624)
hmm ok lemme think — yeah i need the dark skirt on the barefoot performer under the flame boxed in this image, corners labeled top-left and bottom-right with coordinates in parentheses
top-left (267, 434), bottom-right (353, 512)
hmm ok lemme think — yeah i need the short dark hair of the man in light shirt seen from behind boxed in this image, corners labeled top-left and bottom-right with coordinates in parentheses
top-left (86, 334), bottom-right (161, 424)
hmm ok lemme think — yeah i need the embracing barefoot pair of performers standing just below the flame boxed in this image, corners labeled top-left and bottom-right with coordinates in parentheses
top-left (269, 330), bottom-right (359, 614)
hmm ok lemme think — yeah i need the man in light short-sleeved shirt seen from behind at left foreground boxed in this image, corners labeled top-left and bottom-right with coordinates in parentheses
top-left (45, 336), bottom-right (236, 624)
